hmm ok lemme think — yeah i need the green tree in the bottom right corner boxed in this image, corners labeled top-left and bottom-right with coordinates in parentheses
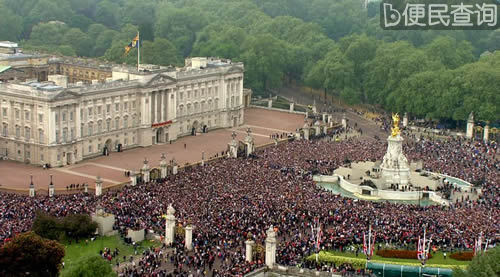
top-left (453, 246), bottom-right (500, 277)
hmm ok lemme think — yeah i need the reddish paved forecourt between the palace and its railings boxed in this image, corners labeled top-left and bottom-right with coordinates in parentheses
top-left (0, 108), bottom-right (304, 193)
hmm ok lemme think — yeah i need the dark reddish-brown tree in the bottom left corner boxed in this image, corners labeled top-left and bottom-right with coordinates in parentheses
top-left (0, 232), bottom-right (64, 276)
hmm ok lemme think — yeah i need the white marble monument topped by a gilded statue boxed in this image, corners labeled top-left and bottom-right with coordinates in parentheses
top-left (379, 114), bottom-right (410, 189)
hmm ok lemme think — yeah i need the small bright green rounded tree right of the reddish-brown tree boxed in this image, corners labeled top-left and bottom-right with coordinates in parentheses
top-left (64, 255), bottom-right (116, 277)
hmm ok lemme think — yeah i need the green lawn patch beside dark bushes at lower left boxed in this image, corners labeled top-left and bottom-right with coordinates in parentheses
top-left (61, 235), bottom-right (160, 276)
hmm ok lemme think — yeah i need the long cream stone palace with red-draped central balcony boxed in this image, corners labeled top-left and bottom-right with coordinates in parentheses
top-left (0, 58), bottom-right (250, 166)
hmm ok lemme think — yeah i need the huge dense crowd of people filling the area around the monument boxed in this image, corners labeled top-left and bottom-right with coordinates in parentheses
top-left (0, 134), bottom-right (500, 276)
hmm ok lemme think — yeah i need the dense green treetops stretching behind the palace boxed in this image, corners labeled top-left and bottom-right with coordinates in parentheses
top-left (0, 0), bottom-right (500, 121)
